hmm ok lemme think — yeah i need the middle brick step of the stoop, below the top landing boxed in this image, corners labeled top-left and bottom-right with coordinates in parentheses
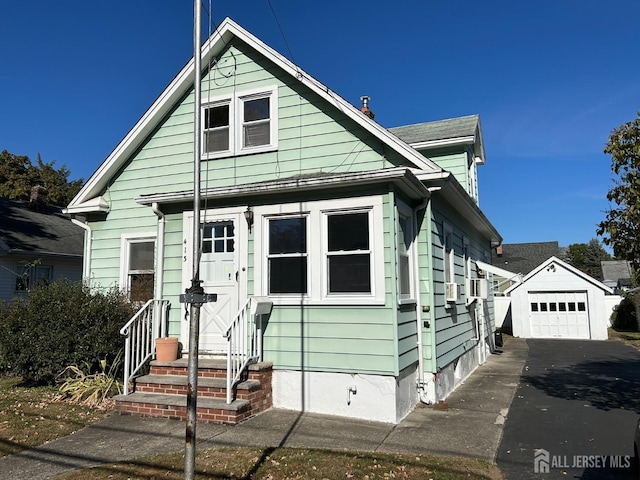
top-left (135, 374), bottom-right (260, 400)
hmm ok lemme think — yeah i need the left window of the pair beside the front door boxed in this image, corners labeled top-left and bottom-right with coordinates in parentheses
top-left (267, 216), bottom-right (308, 294)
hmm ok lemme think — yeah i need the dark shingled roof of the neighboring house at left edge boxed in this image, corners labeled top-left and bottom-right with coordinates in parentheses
top-left (0, 198), bottom-right (84, 257)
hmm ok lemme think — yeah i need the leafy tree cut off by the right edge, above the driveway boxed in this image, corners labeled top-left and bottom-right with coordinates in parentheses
top-left (597, 112), bottom-right (640, 278)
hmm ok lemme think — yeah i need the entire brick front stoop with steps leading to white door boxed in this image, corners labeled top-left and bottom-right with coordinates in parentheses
top-left (115, 358), bottom-right (273, 424)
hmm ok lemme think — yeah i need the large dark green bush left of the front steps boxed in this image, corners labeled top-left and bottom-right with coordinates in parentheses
top-left (0, 280), bottom-right (134, 385)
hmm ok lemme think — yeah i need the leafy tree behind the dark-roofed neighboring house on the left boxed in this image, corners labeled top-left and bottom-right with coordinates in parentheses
top-left (0, 150), bottom-right (84, 207)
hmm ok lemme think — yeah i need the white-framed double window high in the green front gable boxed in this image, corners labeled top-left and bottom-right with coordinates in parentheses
top-left (202, 87), bottom-right (278, 158)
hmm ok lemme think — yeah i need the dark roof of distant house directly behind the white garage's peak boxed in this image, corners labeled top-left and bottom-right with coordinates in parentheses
top-left (491, 242), bottom-right (560, 275)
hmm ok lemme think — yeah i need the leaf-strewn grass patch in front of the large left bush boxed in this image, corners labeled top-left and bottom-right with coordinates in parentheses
top-left (0, 377), bottom-right (105, 457)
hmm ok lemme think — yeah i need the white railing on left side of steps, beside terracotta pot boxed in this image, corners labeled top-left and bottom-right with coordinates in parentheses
top-left (120, 299), bottom-right (169, 395)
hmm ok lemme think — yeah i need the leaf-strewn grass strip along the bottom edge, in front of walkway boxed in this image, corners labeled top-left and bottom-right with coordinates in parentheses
top-left (56, 448), bottom-right (502, 480)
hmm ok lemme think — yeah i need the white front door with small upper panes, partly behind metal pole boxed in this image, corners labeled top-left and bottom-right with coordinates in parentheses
top-left (182, 209), bottom-right (248, 354)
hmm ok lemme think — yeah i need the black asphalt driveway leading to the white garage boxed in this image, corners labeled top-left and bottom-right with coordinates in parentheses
top-left (497, 340), bottom-right (640, 480)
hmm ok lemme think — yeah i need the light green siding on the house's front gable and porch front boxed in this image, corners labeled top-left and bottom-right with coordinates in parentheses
top-left (90, 35), bottom-right (424, 375)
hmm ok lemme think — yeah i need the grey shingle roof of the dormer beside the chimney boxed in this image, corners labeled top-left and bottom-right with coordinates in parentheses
top-left (389, 115), bottom-right (480, 144)
